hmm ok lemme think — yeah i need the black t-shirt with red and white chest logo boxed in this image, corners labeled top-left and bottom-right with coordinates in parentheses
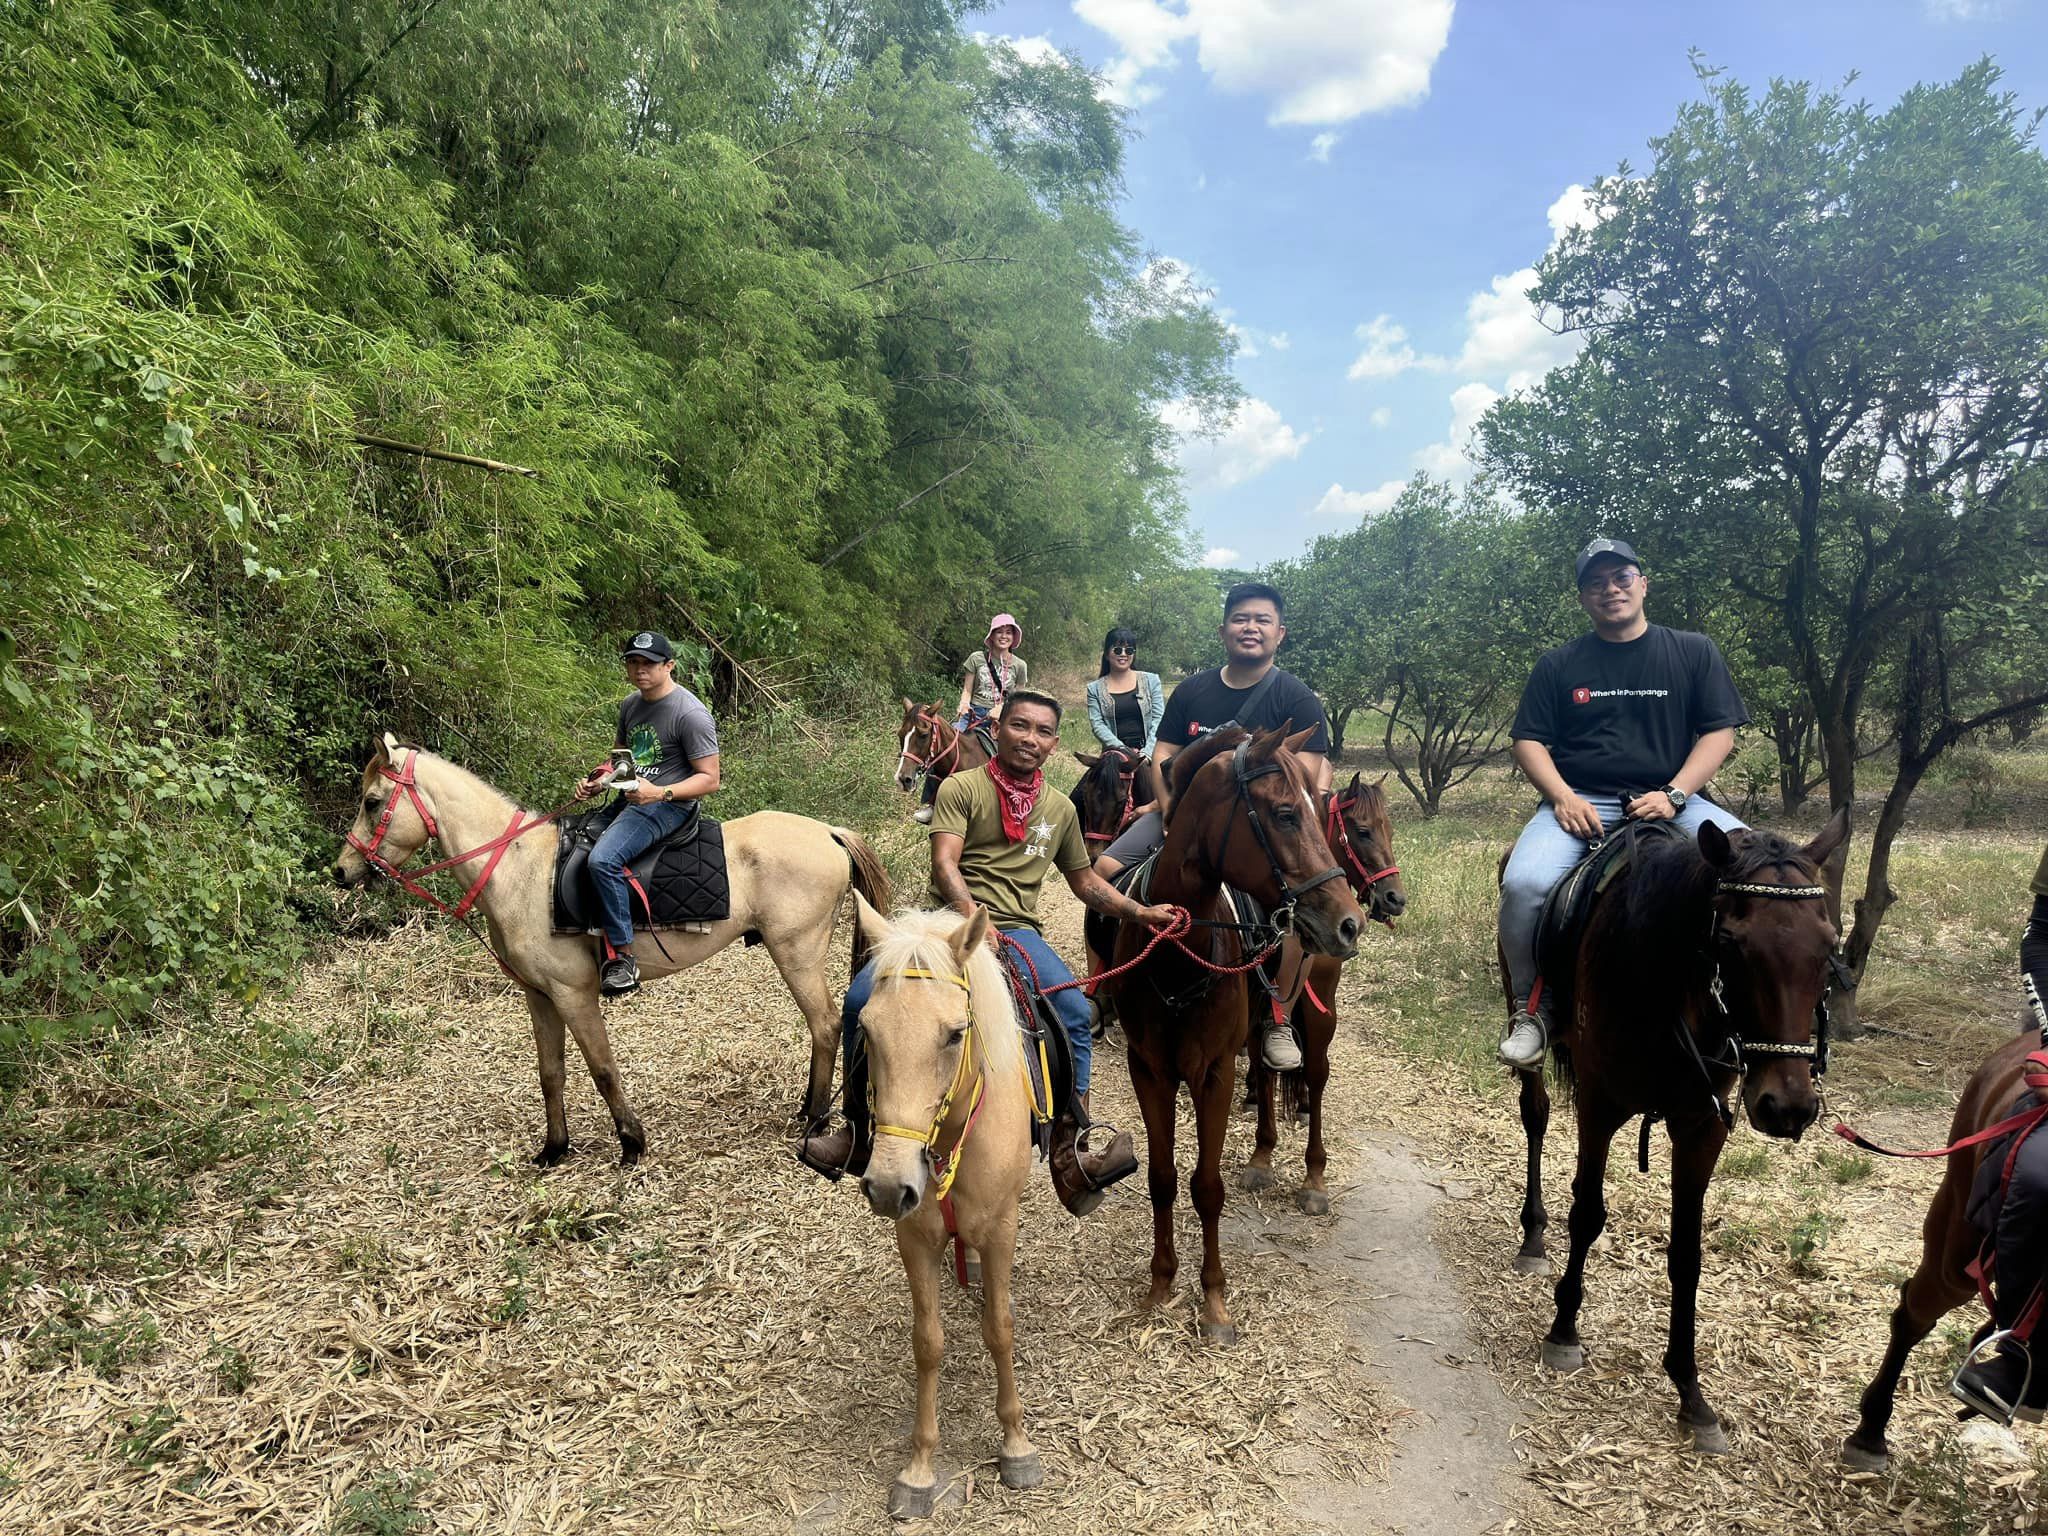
top-left (1511, 625), bottom-right (1749, 795)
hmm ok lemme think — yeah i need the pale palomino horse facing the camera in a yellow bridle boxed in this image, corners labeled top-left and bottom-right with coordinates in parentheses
top-left (854, 897), bottom-right (1042, 1520)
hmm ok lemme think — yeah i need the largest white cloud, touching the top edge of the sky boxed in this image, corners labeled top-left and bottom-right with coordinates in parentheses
top-left (1073, 0), bottom-right (1452, 125)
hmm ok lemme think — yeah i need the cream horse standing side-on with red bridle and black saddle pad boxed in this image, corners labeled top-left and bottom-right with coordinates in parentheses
top-left (334, 733), bottom-right (889, 1167)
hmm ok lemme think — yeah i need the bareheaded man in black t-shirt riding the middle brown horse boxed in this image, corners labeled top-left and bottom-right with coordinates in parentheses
top-left (1096, 582), bottom-right (1329, 1071)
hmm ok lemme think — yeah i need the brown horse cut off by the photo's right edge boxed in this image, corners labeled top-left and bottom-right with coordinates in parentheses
top-left (1841, 1028), bottom-right (2042, 1473)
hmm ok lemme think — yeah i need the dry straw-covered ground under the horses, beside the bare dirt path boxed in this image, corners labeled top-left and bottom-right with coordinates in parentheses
top-left (0, 729), bottom-right (2048, 1534)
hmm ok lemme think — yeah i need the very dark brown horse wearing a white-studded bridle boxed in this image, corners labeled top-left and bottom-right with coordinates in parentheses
top-left (1530, 811), bottom-right (1849, 1454)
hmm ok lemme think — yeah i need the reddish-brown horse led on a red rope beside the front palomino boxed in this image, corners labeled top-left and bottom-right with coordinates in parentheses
top-left (1112, 727), bottom-right (1366, 1343)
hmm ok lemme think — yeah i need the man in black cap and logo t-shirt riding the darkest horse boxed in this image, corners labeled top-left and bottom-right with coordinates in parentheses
top-left (1501, 539), bottom-right (1749, 1067)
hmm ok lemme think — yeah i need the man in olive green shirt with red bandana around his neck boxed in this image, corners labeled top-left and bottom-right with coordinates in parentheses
top-left (797, 690), bottom-right (1174, 1217)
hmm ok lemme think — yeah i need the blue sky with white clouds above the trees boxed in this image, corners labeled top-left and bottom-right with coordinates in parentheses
top-left (971, 0), bottom-right (2048, 565)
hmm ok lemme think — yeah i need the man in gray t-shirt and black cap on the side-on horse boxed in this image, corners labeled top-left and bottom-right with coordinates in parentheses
top-left (575, 629), bottom-right (719, 995)
